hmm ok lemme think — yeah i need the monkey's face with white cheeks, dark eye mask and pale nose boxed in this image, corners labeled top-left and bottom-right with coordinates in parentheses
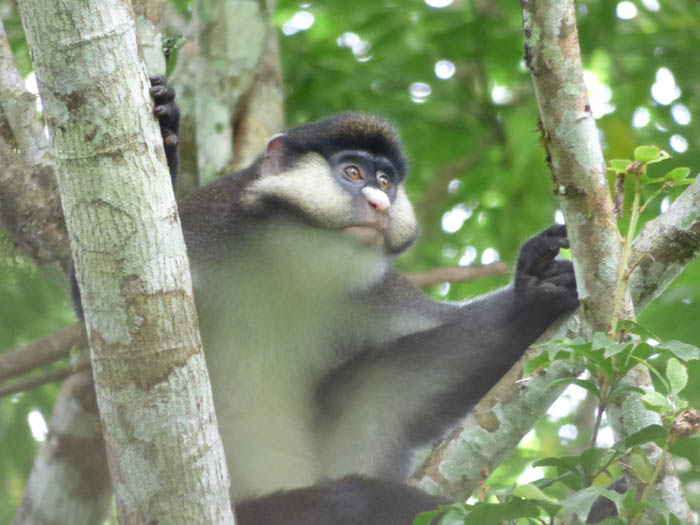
top-left (242, 140), bottom-right (418, 254)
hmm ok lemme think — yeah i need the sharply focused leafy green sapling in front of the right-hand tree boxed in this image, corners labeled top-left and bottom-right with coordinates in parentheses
top-left (446, 135), bottom-right (700, 525)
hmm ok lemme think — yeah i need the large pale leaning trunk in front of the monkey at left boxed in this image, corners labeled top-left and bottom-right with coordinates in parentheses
top-left (19, 0), bottom-right (233, 524)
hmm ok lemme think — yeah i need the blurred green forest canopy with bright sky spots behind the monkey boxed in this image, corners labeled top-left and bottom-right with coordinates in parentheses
top-left (0, 0), bottom-right (700, 523)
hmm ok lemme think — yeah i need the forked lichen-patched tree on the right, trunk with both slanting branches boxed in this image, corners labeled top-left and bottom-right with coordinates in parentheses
top-left (412, 0), bottom-right (700, 510)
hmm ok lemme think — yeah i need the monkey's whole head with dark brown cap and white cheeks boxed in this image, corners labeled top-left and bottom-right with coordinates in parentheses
top-left (241, 114), bottom-right (418, 254)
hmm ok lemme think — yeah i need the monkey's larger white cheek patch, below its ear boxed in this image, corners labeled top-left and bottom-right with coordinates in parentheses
top-left (241, 153), bottom-right (352, 227)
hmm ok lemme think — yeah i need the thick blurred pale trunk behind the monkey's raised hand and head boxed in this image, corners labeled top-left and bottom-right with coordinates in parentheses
top-left (170, 0), bottom-right (284, 195)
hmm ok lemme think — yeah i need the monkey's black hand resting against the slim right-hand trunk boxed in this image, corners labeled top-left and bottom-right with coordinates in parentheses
top-left (514, 225), bottom-right (578, 315)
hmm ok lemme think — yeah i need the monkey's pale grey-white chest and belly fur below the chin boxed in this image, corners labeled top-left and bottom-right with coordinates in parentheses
top-left (193, 225), bottom-right (400, 499)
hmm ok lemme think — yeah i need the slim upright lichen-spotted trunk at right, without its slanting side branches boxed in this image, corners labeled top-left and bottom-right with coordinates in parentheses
top-left (522, 0), bottom-right (689, 517)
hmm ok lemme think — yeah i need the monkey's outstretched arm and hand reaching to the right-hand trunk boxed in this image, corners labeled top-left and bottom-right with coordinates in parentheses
top-left (317, 223), bottom-right (578, 479)
